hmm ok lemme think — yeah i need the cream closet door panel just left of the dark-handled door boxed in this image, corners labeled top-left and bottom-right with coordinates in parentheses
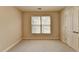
top-left (66, 7), bottom-right (73, 47)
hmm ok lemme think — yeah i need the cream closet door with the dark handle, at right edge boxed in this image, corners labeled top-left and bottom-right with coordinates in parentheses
top-left (72, 7), bottom-right (79, 51)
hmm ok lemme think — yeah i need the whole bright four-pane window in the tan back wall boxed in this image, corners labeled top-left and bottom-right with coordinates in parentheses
top-left (32, 16), bottom-right (51, 34)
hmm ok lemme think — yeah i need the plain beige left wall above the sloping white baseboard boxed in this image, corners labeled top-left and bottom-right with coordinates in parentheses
top-left (0, 7), bottom-right (22, 51)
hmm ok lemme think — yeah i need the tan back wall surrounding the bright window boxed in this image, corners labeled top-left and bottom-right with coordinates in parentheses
top-left (23, 12), bottom-right (59, 39)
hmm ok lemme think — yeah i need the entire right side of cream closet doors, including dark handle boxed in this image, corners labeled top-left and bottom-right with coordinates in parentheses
top-left (61, 7), bottom-right (79, 51)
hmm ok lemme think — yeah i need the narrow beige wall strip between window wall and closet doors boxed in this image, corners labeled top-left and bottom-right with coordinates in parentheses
top-left (60, 9), bottom-right (66, 42)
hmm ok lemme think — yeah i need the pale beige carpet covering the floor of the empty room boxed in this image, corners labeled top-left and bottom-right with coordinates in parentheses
top-left (8, 40), bottom-right (74, 52)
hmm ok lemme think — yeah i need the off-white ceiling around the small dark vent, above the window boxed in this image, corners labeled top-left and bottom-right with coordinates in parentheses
top-left (16, 6), bottom-right (64, 12)
